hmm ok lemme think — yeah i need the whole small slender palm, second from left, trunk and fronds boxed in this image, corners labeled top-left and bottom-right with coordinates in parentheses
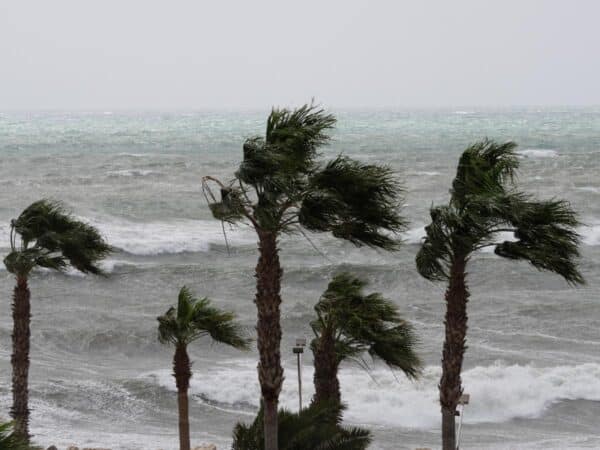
top-left (157, 286), bottom-right (250, 450)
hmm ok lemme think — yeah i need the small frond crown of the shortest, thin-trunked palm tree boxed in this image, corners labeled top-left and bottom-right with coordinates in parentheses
top-left (157, 286), bottom-right (250, 350)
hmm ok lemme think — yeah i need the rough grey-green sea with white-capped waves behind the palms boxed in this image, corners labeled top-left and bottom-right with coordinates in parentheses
top-left (0, 108), bottom-right (600, 449)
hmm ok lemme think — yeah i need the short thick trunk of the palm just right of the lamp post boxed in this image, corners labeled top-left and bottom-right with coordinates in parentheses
top-left (313, 329), bottom-right (342, 404)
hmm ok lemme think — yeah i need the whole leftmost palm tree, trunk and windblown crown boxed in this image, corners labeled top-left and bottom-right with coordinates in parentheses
top-left (4, 200), bottom-right (111, 440)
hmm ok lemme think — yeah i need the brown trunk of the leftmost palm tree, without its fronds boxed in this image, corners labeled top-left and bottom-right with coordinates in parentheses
top-left (10, 275), bottom-right (31, 441)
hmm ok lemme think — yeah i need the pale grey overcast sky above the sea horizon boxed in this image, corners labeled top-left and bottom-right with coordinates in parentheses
top-left (0, 0), bottom-right (600, 110)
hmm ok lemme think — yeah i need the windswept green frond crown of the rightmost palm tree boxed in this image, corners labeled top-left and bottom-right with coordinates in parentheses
top-left (416, 140), bottom-right (584, 284)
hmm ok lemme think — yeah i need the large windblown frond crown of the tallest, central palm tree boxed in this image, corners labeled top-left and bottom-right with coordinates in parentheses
top-left (205, 105), bottom-right (406, 249)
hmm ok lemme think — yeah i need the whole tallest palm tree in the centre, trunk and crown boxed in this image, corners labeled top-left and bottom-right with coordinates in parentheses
top-left (203, 105), bottom-right (405, 450)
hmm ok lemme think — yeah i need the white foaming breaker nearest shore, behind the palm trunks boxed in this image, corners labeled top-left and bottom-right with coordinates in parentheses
top-left (142, 362), bottom-right (600, 429)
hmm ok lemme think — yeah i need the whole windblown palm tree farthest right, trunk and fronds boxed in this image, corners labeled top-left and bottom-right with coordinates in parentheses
top-left (416, 140), bottom-right (584, 450)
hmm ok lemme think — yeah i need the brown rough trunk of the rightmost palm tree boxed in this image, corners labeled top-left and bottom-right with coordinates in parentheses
top-left (440, 257), bottom-right (469, 450)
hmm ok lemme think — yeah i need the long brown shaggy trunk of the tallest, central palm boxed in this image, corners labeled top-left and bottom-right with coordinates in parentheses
top-left (255, 230), bottom-right (283, 450)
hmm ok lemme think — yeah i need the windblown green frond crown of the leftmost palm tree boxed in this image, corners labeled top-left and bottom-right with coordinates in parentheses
top-left (4, 200), bottom-right (112, 276)
